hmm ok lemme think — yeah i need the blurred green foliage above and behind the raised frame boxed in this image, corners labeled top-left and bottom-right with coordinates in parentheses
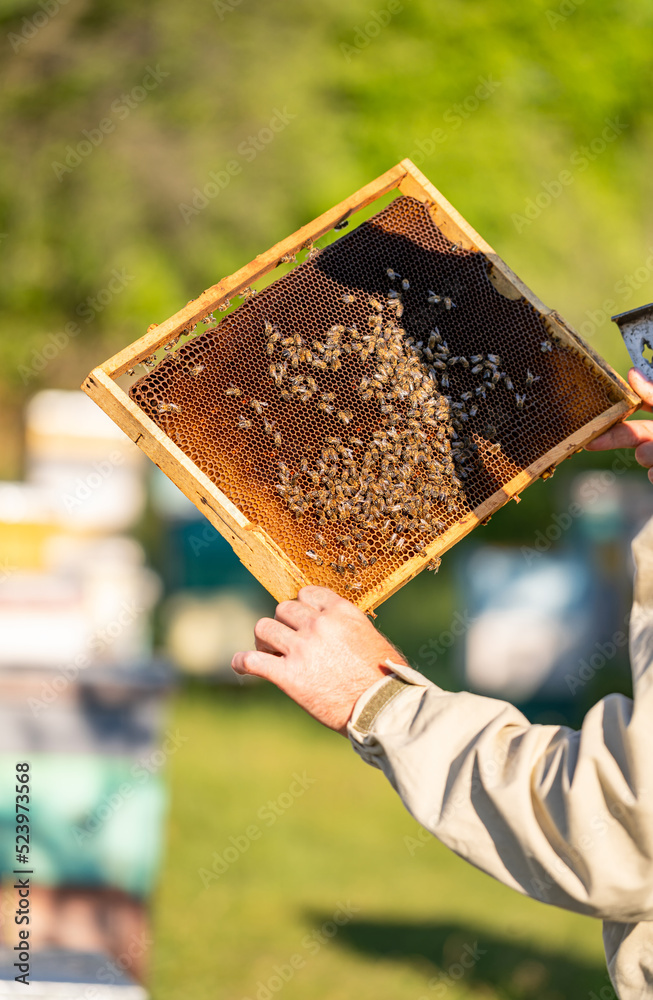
top-left (0, 0), bottom-right (653, 471)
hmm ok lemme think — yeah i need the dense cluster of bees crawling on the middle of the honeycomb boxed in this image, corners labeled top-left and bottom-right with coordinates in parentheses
top-left (213, 267), bottom-right (540, 590)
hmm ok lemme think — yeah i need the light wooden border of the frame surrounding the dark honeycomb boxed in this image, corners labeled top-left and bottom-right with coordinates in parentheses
top-left (82, 160), bottom-right (640, 611)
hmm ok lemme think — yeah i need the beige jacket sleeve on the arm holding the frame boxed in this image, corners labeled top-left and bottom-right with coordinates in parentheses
top-left (349, 521), bottom-right (653, 996)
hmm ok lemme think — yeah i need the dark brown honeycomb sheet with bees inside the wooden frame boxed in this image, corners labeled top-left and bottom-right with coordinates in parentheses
top-left (130, 196), bottom-right (611, 603)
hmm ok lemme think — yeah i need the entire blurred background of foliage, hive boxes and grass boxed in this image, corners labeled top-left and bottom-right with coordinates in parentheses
top-left (0, 0), bottom-right (653, 1000)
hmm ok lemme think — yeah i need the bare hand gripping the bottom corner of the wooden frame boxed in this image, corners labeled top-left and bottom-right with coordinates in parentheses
top-left (231, 587), bottom-right (406, 735)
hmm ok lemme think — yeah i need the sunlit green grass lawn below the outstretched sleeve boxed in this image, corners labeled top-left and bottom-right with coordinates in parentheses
top-left (151, 685), bottom-right (606, 1000)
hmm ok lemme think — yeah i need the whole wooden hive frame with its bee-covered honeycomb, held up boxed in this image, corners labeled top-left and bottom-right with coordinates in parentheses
top-left (83, 160), bottom-right (639, 611)
